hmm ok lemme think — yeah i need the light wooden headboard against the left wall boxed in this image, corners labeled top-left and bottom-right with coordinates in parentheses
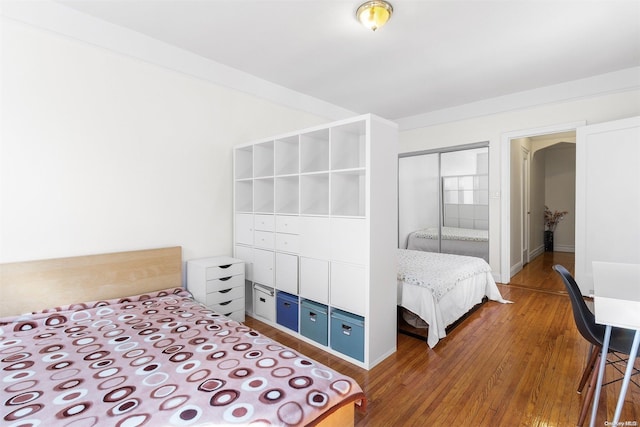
top-left (0, 246), bottom-right (182, 317)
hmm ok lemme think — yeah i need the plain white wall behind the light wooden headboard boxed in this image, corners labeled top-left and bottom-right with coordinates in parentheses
top-left (0, 17), bottom-right (328, 262)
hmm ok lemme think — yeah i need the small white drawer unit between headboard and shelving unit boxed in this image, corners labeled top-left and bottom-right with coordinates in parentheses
top-left (187, 256), bottom-right (245, 322)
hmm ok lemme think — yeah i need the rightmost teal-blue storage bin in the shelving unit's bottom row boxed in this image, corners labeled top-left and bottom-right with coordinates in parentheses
top-left (331, 309), bottom-right (364, 362)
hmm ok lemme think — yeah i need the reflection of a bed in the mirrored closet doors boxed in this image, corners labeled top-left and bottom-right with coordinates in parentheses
top-left (407, 227), bottom-right (489, 261)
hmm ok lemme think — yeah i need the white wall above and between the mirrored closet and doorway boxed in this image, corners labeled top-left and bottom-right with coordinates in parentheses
top-left (400, 89), bottom-right (640, 277)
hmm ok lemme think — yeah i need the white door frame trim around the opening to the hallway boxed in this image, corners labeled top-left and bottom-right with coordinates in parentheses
top-left (500, 120), bottom-right (587, 283)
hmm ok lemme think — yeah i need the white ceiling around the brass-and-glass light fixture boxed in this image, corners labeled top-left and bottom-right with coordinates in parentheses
top-left (48, 0), bottom-right (640, 119)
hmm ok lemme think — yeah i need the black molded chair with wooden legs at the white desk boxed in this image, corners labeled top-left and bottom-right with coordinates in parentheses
top-left (553, 265), bottom-right (638, 426)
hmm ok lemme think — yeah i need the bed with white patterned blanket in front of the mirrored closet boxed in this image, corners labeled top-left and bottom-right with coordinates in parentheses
top-left (396, 249), bottom-right (509, 348)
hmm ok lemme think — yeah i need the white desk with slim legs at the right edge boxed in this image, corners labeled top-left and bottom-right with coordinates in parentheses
top-left (590, 261), bottom-right (640, 427)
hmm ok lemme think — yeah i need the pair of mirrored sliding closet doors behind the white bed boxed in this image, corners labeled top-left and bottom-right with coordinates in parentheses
top-left (398, 143), bottom-right (489, 262)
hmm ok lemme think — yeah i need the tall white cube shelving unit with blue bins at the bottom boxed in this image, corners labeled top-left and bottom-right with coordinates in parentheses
top-left (234, 115), bottom-right (397, 369)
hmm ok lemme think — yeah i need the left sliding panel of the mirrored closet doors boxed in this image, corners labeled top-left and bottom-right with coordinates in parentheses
top-left (398, 153), bottom-right (440, 247)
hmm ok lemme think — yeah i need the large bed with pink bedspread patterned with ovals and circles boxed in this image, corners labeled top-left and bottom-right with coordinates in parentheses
top-left (0, 288), bottom-right (365, 426)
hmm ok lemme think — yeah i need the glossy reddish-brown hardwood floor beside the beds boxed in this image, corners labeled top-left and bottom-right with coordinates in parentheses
top-left (245, 253), bottom-right (640, 426)
